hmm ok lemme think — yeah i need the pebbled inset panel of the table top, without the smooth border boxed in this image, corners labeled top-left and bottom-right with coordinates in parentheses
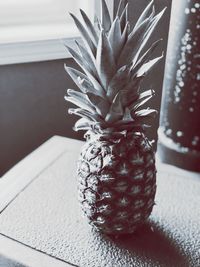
top-left (0, 137), bottom-right (200, 267)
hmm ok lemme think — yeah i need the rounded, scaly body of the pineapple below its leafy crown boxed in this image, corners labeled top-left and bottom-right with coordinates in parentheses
top-left (78, 133), bottom-right (156, 235)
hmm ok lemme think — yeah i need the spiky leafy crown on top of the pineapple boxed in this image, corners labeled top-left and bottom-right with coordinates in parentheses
top-left (65, 0), bottom-right (165, 137)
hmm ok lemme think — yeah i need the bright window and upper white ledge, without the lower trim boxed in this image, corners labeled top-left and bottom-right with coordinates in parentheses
top-left (0, 0), bottom-right (94, 43)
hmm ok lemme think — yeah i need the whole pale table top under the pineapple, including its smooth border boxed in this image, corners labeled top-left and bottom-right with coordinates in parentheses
top-left (0, 136), bottom-right (200, 267)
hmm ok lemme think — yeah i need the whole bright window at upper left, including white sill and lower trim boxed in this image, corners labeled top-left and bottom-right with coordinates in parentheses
top-left (0, 0), bottom-right (100, 65)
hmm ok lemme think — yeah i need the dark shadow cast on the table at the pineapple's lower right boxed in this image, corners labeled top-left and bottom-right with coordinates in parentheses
top-left (104, 222), bottom-right (189, 267)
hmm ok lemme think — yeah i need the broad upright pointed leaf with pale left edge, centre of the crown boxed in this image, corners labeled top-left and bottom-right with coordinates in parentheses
top-left (96, 30), bottom-right (116, 90)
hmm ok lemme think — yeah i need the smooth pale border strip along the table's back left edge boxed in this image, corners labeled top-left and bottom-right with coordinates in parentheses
top-left (0, 136), bottom-right (82, 213)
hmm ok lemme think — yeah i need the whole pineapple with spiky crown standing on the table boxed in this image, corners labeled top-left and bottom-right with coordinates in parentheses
top-left (65, 0), bottom-right (164, 235)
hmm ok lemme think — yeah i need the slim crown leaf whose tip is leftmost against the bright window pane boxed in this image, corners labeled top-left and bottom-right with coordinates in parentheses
top-left (70, 13), bottom-right (96, 56)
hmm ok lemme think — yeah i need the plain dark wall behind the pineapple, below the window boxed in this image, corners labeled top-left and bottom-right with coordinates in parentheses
top-left (0, 0), bottom-right (171, 176)
